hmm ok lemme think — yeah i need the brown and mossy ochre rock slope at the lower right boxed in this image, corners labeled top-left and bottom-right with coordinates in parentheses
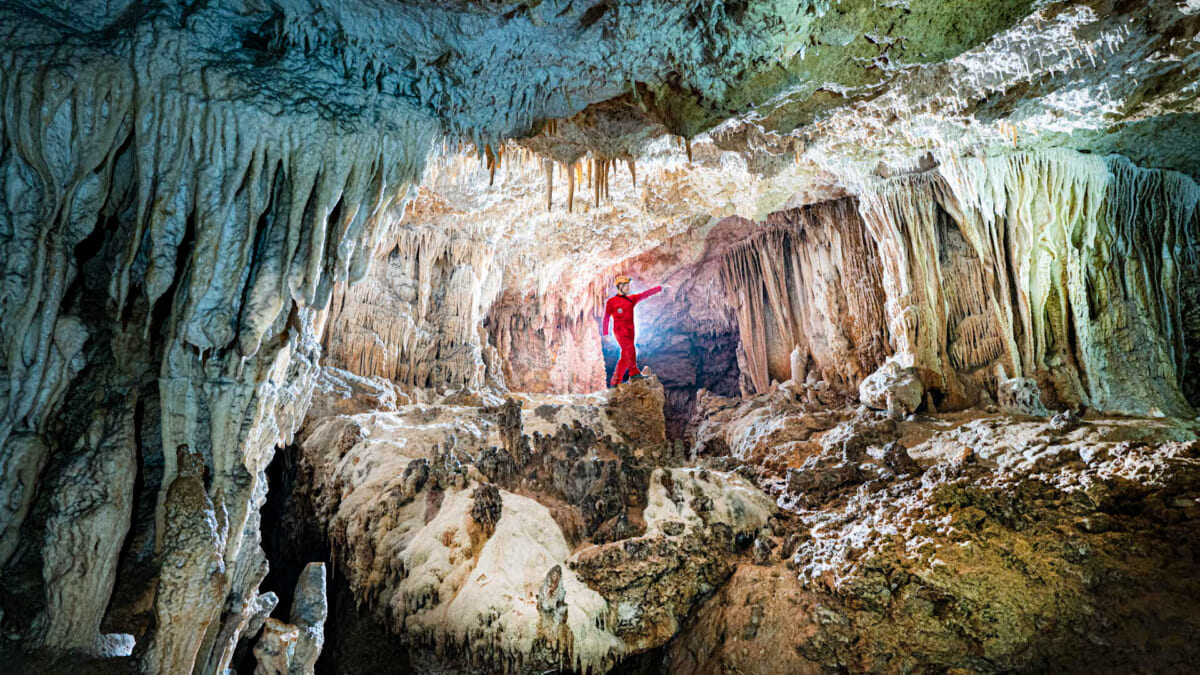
top-left (668, 419), bottom-right (1200, 673)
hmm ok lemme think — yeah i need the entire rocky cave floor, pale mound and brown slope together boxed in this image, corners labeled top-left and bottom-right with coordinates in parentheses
top-left (280, 369), bottom-right (1200, 673)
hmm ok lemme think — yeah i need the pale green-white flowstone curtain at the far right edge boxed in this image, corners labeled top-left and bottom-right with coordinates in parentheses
top-left (941, 151), bottom-right (1200, 414)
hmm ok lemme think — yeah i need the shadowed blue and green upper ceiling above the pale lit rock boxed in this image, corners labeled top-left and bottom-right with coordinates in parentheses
top-left (21, 0), bottom-right (1200, 163)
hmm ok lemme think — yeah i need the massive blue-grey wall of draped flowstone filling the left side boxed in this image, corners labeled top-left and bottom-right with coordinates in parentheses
top-left (0, 7), bottom-right (438, 673)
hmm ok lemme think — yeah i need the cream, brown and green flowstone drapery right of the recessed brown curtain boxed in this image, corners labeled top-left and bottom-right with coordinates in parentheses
top-left (863, 151), bottom-right (1200, 416)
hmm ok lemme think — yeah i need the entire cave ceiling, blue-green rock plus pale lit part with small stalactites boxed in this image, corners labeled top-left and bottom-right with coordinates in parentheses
top-left (9, 0), bottom-right (1200, 357)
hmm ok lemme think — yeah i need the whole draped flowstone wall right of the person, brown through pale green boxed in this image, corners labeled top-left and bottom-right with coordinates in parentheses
top-left (722, 150), bottom-right (1200, 416)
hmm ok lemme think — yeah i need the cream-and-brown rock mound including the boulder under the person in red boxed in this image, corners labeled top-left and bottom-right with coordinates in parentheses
top-left (300, 378), bottom-right (775, 673)
